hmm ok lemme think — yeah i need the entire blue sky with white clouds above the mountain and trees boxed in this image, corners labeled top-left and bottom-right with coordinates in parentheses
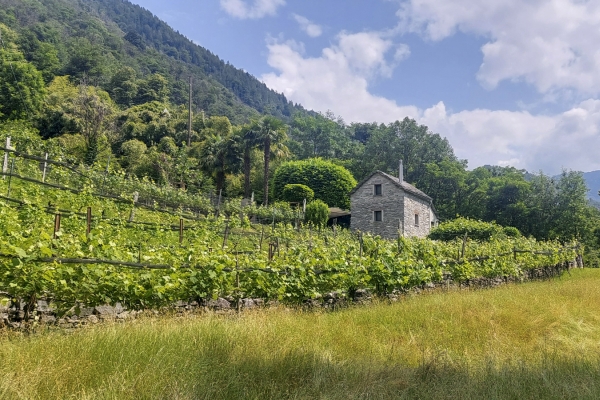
top-left (133, 0), bottom-right (600, 174)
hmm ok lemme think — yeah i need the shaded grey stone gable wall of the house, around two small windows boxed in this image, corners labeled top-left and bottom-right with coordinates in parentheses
top-left (350, 174), bottom-right (404, 239)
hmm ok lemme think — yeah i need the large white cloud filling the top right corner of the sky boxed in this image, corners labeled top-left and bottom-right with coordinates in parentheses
top-left (398, 0), bottom-right (600, 95)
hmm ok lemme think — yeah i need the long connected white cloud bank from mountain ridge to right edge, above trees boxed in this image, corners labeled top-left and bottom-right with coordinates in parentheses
top-left (262, 33), bottom-right (600, 174)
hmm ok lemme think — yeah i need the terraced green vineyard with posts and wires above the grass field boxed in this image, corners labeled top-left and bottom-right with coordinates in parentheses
top-left (0, 147), bottom-right (578, 313)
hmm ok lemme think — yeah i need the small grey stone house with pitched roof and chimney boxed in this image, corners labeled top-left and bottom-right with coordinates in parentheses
top-left (350, 162), bottom-right (438, 239)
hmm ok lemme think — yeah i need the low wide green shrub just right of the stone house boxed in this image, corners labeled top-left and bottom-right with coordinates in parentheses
top-left (429, 217), bottom-right (506, 242)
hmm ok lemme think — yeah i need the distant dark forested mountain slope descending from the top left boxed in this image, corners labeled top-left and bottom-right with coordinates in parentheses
top-left (0, 0), bottom-right (305, 122)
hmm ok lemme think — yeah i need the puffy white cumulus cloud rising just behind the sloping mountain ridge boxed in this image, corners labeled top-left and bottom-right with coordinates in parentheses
top-left (262, 32), bottom-right (418, 122)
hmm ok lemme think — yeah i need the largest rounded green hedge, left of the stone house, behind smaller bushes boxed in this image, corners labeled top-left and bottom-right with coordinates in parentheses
top-left (273, 158), bottom-right (356, 209)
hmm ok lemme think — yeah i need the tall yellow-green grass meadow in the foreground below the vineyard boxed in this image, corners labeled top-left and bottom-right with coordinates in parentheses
top-left (0, 270), bottom-right (600, 399)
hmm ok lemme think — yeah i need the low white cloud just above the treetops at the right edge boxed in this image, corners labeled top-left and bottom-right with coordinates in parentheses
top-left (419, 100), bottom-right (600, 174)
